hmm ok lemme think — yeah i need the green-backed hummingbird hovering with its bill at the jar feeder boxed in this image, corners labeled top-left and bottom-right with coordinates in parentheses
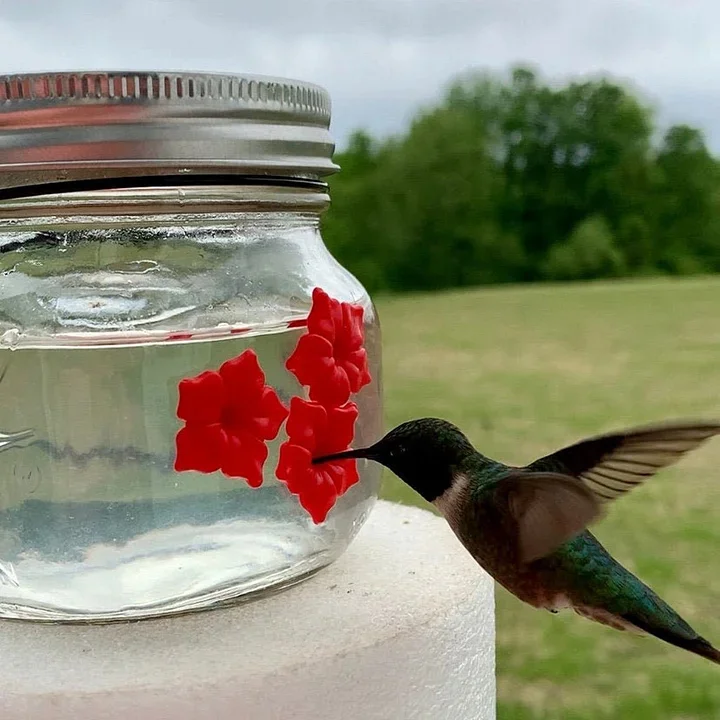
top-left (313, 418), bottom-right (720, 664)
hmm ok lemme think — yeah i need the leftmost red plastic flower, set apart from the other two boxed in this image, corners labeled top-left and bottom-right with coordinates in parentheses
top-left (175, 350), bottom-right (288, 487)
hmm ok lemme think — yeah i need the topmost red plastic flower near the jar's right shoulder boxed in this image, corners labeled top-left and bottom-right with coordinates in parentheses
top-left (285, 288), bottom-right (371, 407)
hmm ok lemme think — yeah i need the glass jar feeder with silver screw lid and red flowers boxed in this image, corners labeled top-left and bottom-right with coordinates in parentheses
top-left (0, 72), bottom-right (382, 621)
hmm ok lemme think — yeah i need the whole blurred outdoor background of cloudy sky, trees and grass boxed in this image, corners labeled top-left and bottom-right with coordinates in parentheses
top-left (0, 0), bottom-right (720, 720)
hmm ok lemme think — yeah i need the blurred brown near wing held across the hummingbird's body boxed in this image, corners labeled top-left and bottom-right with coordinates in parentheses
top-left (486, 470), bottom-right (602, 563)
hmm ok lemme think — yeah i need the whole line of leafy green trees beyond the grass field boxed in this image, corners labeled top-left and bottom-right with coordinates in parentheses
top-left (323, 67), bottom-right (720, 291)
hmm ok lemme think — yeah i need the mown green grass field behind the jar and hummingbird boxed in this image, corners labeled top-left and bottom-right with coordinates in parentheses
top-left (378, 279), bottom-right (720, 720)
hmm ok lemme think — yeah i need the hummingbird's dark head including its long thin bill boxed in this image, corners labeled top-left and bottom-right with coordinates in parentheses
top-left (313, 418), bottom-right (475, 502)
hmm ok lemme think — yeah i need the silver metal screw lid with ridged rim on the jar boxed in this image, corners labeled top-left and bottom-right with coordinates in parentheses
top-left (0, 71), bottom-right (338, 188)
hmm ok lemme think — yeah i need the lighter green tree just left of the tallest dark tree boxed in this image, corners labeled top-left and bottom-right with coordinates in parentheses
top-left (388, 99), bottom-right (523, 289)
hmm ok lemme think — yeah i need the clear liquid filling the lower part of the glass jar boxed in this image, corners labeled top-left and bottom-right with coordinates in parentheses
top-left (0, 327), bottom-right (380, 621)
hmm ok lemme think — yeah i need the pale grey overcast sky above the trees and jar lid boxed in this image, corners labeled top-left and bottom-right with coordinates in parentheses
top-left (0, 0), bottom-right (720, 150)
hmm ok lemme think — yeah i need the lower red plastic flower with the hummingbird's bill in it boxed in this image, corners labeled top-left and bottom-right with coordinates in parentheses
top-left (275, 397), bottom-right (360, 523)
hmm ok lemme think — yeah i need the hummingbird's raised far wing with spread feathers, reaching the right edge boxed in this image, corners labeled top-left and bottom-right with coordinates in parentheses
top-left (525, 421), bottom-right (720, 503)
